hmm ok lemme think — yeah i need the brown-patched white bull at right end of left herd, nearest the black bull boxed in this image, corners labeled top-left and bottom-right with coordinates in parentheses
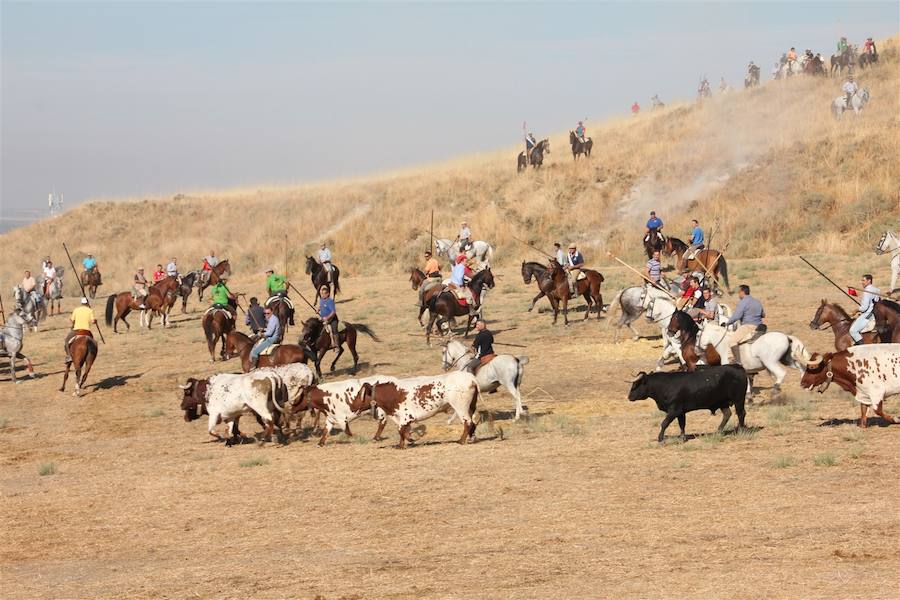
top-left (359, 371), bottom-right (479, 448)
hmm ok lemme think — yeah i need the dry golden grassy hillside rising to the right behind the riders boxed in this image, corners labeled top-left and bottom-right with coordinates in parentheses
top-left (0, 36), bottom-right (900, 292)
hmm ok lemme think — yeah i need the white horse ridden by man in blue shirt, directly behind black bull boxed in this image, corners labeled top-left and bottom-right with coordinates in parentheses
top-left (697, 322), bottom-right (811, 391)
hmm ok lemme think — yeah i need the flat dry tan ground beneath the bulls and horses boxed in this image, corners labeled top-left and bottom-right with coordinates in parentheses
top-left (0, 256), bottom-right (900, 599)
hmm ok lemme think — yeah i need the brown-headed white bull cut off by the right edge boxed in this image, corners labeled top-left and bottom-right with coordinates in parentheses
top-left (800, 344), bottom-right (900, 427)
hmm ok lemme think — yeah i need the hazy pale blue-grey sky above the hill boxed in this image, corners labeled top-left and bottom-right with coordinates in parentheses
top-left (0, 0), bottom-right (900, 217)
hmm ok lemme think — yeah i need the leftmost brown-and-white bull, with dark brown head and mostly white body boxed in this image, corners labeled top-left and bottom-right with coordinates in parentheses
top-left (178, 372), bottom-right (287, 446)
